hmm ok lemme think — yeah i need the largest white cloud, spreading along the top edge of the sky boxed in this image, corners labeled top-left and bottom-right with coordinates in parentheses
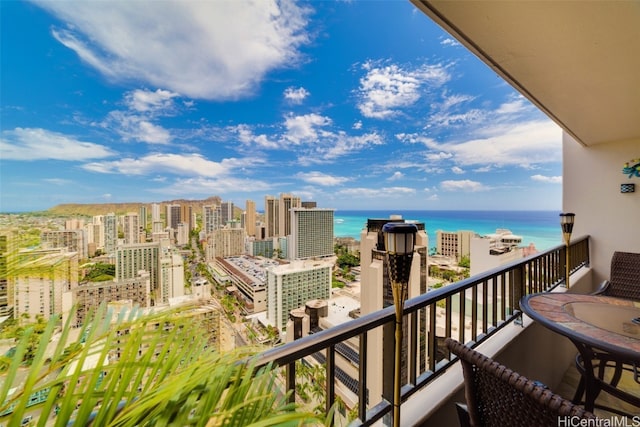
top-left (35, 0), bottom-right (310, 100)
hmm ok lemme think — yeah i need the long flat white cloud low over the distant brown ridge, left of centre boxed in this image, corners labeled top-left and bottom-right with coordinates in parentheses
top-left (82, 154), bottom-right (232, 177)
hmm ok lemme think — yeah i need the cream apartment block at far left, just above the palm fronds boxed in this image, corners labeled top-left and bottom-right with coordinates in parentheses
top-left (13, 252), bottom-right (78, 319)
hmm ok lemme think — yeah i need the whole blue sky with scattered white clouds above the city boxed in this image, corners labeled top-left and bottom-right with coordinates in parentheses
top-left (0, 0), bottom-right (562, 212)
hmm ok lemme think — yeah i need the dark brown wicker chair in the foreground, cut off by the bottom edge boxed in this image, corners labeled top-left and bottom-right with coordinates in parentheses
top-left (446, 338), bottom-right (596, 427)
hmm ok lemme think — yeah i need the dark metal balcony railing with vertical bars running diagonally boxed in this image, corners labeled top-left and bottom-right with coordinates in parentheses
top-left (254, 237), bottom-right (589, 426)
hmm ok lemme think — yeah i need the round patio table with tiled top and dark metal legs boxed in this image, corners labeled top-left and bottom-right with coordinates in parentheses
top-left (520, 293), bottom-right (640, 411)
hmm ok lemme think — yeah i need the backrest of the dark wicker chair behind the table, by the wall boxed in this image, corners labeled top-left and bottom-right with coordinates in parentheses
top-left (604, 252), bottom-right (640, 300)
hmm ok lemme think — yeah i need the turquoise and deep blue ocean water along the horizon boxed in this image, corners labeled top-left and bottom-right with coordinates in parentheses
top-left (334, 210), bottom-right (563, 251)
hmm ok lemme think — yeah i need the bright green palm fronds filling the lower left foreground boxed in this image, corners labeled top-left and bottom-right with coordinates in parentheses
top-left (0, 307), bottom-right (319, 427)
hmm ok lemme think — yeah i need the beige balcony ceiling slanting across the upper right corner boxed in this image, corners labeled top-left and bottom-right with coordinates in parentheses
top-left (411, 0), bottom-right (640, 146)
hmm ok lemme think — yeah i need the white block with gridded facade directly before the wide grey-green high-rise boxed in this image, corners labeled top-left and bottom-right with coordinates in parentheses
top-left (267, 261), bottom-right (333, 331)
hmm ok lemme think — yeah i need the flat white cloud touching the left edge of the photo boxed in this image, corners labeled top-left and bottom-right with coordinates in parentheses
top-left (0, 128), bottom-right (116, 161)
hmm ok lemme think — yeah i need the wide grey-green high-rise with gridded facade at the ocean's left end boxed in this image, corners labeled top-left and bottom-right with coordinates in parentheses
top-left (288, 208), bottom-right (334, 259)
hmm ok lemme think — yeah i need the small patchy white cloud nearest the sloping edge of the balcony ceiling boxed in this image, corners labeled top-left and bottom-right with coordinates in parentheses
top-left (358, 61), bottom-right (450, 119)
